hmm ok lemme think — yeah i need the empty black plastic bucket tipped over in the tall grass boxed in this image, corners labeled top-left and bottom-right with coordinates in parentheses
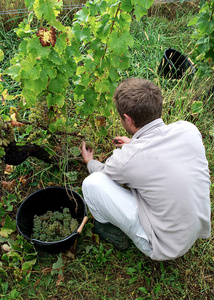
top-left (158, 48), bottom-right (195, 79)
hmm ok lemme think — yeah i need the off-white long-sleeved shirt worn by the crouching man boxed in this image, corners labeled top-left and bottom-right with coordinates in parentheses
top-left (87, 119), bottom-right (211, 260)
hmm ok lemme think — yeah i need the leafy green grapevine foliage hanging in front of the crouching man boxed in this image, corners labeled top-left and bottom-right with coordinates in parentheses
top-left (4, 0), bottom-right (153, 150)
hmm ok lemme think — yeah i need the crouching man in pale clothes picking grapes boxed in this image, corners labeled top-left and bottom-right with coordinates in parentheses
top-left (81, 78), bottom-right (211, 260)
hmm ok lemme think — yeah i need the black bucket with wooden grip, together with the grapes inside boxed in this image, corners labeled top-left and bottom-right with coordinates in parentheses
top-left (16, 186), bottom-right (88, 253)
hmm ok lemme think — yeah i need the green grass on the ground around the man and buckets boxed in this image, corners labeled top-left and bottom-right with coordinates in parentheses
top-left (0, 4), bottom-right (214, 300)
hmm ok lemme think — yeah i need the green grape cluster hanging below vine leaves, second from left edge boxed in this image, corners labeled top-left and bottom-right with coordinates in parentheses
top-left (29, 99), bottom-right (48, 127)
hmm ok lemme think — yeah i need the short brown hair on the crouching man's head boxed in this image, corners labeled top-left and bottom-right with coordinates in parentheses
top-left (114, 78), bottom-right (163, 128)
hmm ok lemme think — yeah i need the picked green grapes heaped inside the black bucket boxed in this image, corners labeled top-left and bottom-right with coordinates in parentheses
top-left (32, 207), bottom-right (78, 242)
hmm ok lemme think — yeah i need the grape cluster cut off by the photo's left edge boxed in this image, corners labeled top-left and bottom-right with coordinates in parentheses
top-left (0, 116), bottom-right (15, 146)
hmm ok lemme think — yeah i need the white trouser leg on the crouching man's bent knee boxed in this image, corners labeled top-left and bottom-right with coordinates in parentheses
top-left (82, 172), bottom-right (151, 256)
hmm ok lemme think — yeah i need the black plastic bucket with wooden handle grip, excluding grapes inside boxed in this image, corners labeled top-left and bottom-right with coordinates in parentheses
top-left (16, 186), bottom-right (87, 253)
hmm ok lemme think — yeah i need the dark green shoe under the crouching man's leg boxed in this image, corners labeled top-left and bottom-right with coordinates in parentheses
top-left (94, 220), bottom-right (129, 250)
